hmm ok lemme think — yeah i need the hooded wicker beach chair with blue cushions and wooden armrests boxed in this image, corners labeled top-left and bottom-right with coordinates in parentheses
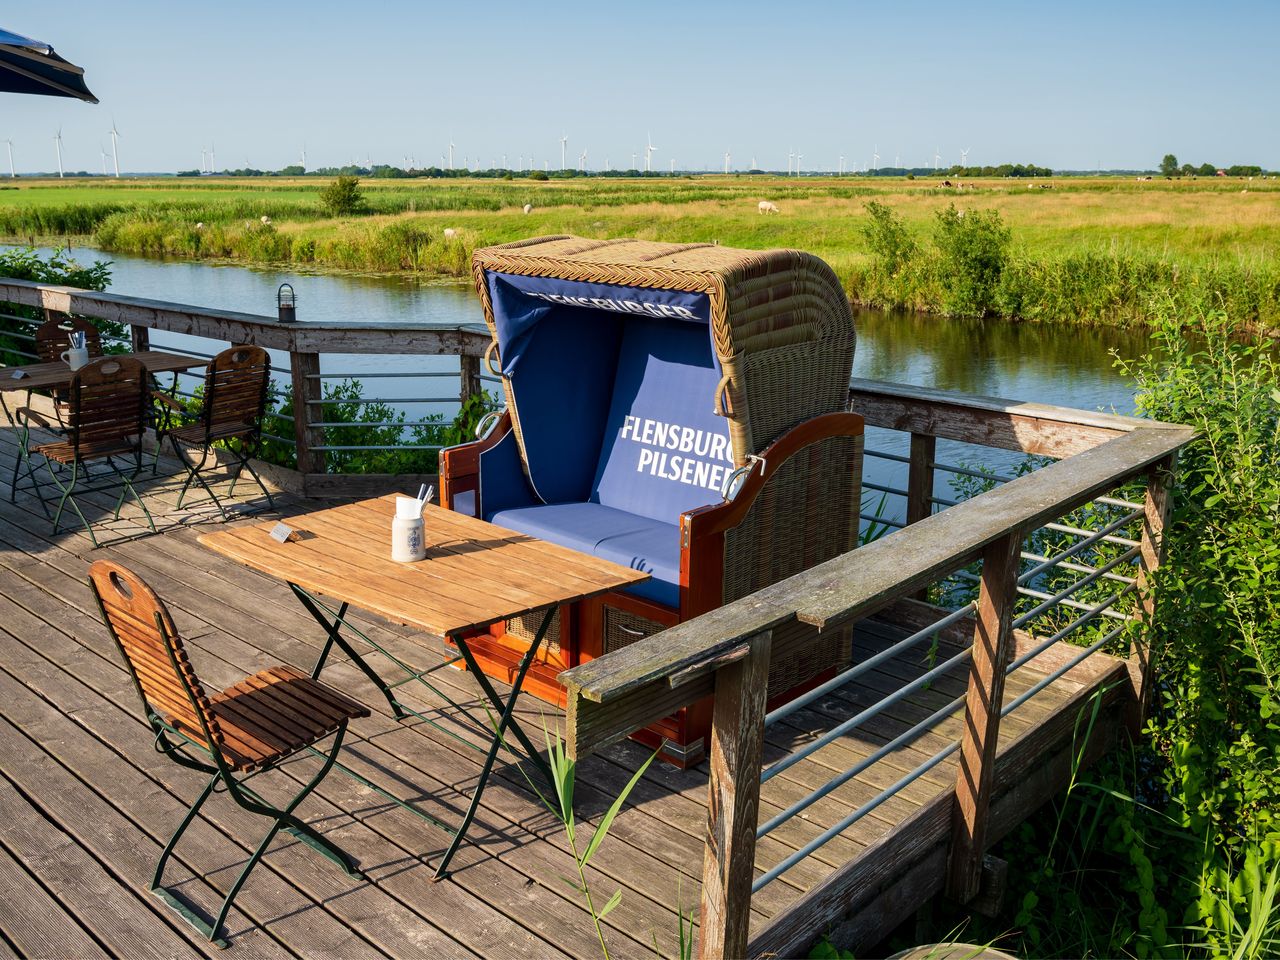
top-left (440, 237), bottom-right (863, 764)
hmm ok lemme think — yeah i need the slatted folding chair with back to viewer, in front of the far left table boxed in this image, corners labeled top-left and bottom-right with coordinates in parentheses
top-left (18, 357), bottom-right (156, 547)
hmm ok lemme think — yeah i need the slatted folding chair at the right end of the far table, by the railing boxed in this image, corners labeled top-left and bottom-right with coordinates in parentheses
top-left (156, 346), bottom-right (275, 520)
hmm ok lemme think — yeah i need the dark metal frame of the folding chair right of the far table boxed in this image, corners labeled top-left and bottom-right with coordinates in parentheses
top-left (152, 346), bottom-right (275, 520)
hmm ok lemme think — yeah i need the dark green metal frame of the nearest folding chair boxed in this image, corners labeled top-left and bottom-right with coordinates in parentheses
top-left (90, 568), bottom-right (367, 950)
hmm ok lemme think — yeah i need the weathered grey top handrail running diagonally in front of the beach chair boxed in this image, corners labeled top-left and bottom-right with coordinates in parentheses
top-left (559, 421), bottom-right (1194, 756)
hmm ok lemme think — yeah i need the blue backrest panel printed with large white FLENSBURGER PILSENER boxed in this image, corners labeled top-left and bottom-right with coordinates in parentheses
top-left (591, 317), bottom-right (733, 524)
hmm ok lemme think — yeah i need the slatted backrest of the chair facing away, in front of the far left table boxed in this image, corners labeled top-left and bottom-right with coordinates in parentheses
top-left (67, 357), bottom-right (150, 456)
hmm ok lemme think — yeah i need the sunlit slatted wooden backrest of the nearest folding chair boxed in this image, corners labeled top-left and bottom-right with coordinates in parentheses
top-left (88, 559), bottom-right (224, 753)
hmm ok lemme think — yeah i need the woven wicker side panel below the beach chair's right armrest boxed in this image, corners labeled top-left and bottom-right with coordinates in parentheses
top-left (724, 436), bottom-right (863, 696)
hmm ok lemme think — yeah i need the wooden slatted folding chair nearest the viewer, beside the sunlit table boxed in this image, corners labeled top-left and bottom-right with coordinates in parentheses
top-left (88, 561), bottom-right (369, 947)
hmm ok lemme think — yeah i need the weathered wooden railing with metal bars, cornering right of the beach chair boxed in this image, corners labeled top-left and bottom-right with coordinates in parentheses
top-left (561, 380), bottom-right (1193, 957)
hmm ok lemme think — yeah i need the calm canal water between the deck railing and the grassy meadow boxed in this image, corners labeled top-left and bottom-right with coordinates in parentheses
top-left (10, 248), bottom-right (1149, 504)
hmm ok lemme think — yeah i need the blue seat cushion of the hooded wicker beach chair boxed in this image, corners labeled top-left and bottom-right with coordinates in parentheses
top-left (485, 503), bottom-right (680, 609)
